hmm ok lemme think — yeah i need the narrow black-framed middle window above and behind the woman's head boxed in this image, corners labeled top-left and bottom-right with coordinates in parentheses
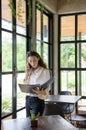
top-left (36, 5), bottom-right (53, 70)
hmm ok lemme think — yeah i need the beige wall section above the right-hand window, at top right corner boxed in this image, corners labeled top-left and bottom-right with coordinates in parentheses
top-left (57, 0), bottom-right (86, 14)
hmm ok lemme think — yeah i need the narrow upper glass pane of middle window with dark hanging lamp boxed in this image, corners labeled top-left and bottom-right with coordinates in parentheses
top-left (43, 15), bottom-right (48, 42)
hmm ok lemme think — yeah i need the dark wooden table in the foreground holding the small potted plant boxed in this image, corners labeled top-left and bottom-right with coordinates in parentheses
top-left (2, 115), bottom-right (78, 130)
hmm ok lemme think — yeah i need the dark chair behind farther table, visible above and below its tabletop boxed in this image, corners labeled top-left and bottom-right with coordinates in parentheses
top-left (58, 91), bottom-right (74, 114)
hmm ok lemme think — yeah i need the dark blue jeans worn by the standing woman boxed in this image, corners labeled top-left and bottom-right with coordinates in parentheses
top-left (26, 96), bottom-right (45, 117)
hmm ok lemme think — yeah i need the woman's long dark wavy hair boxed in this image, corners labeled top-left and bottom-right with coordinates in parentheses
top-left (27, 51), bottom-right (47, 69)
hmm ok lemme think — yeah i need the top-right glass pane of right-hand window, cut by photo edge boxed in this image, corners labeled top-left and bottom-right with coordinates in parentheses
top-left (77, 15), bottom-right (86, 40)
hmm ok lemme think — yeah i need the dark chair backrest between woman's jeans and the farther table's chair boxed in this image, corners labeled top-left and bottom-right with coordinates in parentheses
top-left (44, 103), bottom-right (64, 118)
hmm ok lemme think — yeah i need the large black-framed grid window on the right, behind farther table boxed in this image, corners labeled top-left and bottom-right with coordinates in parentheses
top-left (59, 13), bottom-right (86, 96)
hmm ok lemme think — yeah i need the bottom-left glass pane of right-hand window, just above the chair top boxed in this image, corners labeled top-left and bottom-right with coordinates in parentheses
top-left (61, 71), bottom-right (75, 95)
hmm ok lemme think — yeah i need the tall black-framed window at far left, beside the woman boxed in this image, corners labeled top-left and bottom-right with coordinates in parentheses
top-left (0, 0), bottom-right (31, 118)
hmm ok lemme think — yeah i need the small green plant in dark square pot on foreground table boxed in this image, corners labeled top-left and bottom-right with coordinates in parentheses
top-left (30, 110), bottom-right (40, 127)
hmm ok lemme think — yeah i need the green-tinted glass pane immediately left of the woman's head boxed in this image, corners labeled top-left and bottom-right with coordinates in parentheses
top-left (17, 36), bottom-right (26, 71)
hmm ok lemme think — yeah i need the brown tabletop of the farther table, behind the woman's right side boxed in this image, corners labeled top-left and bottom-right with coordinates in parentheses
top-left (45, 95), bottom-right (81, 104)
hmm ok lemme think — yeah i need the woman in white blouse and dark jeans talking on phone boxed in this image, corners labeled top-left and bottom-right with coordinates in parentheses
top-left (24, 51), bottom-right (50, 117)
